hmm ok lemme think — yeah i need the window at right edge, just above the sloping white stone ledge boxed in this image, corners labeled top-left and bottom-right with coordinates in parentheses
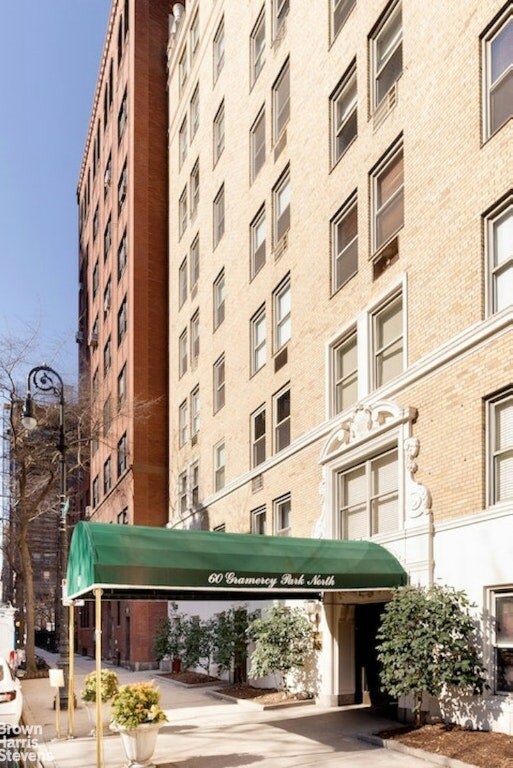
top-left (487, 202), bottom-right (513, 313)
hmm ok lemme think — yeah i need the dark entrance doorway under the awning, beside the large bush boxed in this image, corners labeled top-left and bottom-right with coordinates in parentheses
top-left (355, 603), bottom-right (392, 708)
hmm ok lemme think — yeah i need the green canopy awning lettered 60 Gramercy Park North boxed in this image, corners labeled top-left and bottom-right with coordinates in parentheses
top-left (67, 522), bottom-right (406, 600)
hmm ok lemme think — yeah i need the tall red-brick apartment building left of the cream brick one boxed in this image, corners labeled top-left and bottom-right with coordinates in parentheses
top-left (77, 0), bottom-right (170, 667)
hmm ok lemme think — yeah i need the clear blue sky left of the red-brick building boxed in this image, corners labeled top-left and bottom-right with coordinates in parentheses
top-left (0, 0), bottom-right (111, 384)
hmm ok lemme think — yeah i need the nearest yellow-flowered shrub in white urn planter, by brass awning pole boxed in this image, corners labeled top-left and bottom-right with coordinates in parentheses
top-left (111, 683), bottom-right (167, 768)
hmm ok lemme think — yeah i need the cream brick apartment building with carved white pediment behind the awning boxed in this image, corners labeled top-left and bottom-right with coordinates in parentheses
top-left (168, 0), bottom-right (513, 733)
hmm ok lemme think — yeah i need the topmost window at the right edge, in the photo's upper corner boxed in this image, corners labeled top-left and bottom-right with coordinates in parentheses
top-left (484, 5), bottom-right (513, 138)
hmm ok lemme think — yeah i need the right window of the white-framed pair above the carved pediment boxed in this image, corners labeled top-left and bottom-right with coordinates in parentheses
top-left (372, 293), bottom-right (404, 388)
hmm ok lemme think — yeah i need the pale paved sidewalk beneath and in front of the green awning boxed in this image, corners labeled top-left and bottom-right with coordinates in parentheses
top-left (19, 651), bottom-right (435, 768)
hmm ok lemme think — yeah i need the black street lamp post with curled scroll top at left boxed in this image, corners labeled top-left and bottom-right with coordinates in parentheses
top-left (22, 365), bottom-right (69, 707)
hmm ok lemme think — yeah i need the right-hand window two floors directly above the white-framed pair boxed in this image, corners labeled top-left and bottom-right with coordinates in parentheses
top-left (371, 3), bottom-right (403, 109)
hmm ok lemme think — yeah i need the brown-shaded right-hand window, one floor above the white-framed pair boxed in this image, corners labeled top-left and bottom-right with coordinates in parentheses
top-left (372, 140), bottom-right (404, 251)
